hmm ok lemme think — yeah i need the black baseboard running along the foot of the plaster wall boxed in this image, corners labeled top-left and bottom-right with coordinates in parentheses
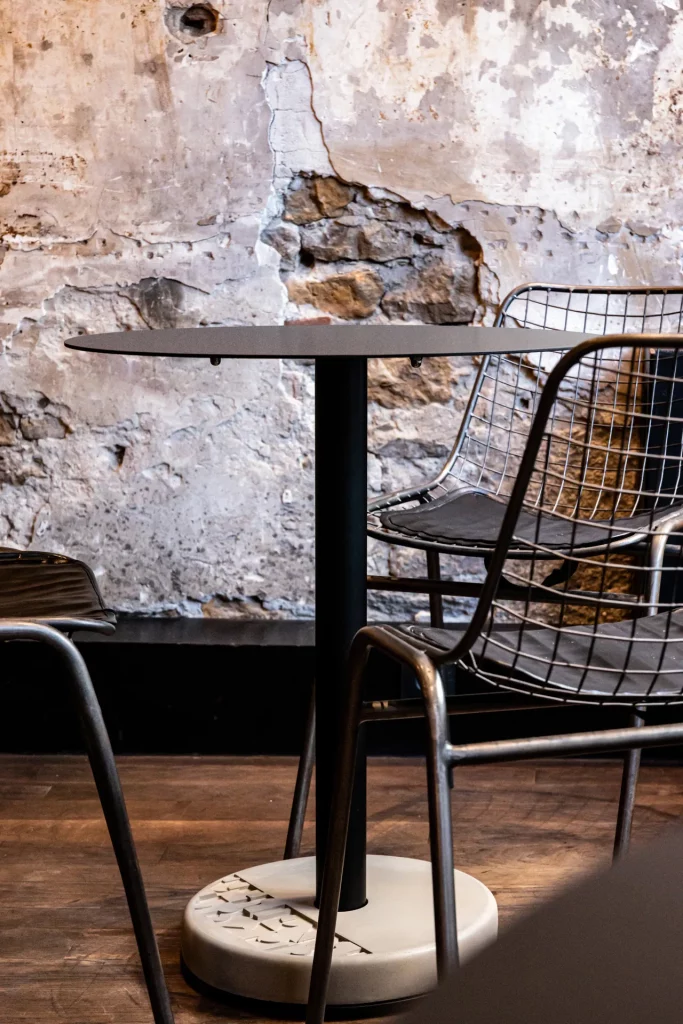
top-left (0, 618), bottom-right (683, 761)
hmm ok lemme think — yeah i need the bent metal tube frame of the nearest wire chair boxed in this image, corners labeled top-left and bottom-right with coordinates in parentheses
top-left (306, 335), bottom-right (683, 1024)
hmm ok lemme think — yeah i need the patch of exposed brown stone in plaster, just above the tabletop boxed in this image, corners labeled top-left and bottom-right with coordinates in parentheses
top-left (262, 176), bottom-right (484, 324)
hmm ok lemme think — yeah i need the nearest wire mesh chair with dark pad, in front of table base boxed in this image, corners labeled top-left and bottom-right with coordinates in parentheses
top-left (307, 334), bottom-right (683, 1024)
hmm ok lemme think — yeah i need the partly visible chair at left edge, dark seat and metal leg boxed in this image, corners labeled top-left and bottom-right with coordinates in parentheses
top-left (0, 548), bottom-right (173, 1024)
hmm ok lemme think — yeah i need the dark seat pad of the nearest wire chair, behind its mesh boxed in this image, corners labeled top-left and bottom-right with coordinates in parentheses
top-left (400, 608), bottom-right (683, 702)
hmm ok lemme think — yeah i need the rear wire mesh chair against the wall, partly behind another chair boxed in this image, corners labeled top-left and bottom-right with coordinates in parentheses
top-left (286, 284), bottom-right (683, 856)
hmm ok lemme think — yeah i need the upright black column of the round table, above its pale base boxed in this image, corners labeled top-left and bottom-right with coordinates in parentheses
top-left (315, 356), bottom-right (368, 910)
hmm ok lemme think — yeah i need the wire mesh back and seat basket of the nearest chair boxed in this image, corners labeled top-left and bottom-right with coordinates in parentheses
top-left (463, 335), bottom-right (683, 705)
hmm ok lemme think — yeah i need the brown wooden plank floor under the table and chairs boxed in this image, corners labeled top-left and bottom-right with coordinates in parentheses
top-left (0, 756), bottom-right (683, 1024)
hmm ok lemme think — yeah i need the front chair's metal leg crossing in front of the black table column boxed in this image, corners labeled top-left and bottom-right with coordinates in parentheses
top-left (306, 635), bottom-right (369, 1024)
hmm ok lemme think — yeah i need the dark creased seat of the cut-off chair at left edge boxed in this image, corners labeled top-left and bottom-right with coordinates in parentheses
top-left (0, 548), bottom-right (116, 633)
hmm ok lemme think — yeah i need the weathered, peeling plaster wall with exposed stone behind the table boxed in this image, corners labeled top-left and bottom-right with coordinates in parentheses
top-left (0, 0), bottom-right (683, 615)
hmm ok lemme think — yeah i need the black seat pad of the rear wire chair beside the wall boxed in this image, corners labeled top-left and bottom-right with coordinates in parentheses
top-left (380, 490), bottom-right (683, 551)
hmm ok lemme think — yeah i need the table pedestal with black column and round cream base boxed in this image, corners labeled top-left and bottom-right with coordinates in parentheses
top-left (182, 355), bottom-right (497, 1003)
